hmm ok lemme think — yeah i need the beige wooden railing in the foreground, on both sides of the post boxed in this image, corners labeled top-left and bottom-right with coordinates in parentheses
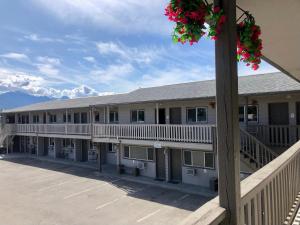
top-left (182, 141), bottom-right (300, 225)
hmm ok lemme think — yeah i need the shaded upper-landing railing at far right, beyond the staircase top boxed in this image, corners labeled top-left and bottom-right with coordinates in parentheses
top-left (248, 125), bottom-right (300, 147)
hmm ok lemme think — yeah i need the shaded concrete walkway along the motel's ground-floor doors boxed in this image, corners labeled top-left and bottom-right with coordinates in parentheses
top-left (0, 154), bottom-right (217, 198)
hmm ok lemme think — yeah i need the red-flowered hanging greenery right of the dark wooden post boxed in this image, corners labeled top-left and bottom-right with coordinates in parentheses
top-left (237, 14), bottom-right (262, 70)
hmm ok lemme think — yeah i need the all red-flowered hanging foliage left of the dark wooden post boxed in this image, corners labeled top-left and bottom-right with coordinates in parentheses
top-left (165, 0), bottom-right (226, 45)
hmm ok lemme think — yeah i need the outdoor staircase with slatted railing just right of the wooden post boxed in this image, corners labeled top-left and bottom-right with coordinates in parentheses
top-left (240, 128), bottom-right (277, 172)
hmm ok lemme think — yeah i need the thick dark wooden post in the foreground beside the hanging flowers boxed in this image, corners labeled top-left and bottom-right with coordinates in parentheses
top-left (215, 0), bottom-right (240, 225)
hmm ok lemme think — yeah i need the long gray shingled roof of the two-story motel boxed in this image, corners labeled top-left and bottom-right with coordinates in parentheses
top-left (4, 73), bottom-right (300, 112)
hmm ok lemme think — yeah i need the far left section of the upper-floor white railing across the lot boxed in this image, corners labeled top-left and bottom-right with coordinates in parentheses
top-left (15, 124), bottom-right (91, 135)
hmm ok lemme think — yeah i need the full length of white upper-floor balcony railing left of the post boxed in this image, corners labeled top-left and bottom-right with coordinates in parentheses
top-left (6, 124), bottom-right (215, 144)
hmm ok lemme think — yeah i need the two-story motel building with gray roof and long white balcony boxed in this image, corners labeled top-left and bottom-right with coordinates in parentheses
top-left (0, 73), bottom-right (300, 187)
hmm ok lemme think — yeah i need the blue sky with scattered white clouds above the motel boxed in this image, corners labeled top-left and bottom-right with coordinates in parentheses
top-left (0, 0), bottom-right (276, 98)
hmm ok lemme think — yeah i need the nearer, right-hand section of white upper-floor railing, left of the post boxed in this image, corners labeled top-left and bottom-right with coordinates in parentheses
top-left (93, 124), bottom-right (214, 143)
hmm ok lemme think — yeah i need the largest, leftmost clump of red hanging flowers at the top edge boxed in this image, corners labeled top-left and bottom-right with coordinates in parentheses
top-left (165, 0), bottom-right (209, 45)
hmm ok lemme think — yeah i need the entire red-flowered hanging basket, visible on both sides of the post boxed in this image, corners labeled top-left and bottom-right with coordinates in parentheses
top-left (165, 0), bottom-right (262, 70)
